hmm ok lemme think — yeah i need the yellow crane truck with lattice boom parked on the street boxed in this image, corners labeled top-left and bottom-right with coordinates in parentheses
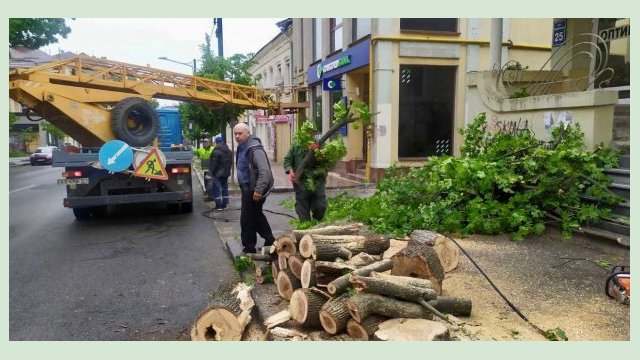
top-left (9, 56), bottom-right (273, 220)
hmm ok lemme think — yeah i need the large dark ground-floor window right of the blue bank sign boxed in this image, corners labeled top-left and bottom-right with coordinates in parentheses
top-left (398, 65), bottom-right (456, 158)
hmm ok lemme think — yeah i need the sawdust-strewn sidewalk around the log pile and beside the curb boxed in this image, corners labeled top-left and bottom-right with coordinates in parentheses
top-left (196, 164), bottom-right (630, 341)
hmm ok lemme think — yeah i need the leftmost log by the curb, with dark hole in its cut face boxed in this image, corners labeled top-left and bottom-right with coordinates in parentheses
top-left (191, 283), bottom-right (255, 341)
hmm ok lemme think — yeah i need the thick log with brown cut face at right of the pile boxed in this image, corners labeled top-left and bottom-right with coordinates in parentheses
top-left (391, 245), bottom-right (444, 295)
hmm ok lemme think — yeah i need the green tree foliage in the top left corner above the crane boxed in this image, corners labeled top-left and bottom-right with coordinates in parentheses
top-left (9, 18), bottom-right (71, 49)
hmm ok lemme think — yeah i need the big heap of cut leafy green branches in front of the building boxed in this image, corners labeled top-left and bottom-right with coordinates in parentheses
top-left (312, 114), bottom-right (620, 241)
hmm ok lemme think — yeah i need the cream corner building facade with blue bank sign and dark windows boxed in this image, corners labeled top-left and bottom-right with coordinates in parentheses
top-left (292, 18), bottom-right (553, 181)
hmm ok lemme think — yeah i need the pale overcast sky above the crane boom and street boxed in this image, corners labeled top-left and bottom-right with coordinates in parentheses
top-left (42, 18), bottom-right (283, 106)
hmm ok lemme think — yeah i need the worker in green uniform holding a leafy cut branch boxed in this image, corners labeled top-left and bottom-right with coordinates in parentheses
top-left (283, 143), bottom-right (327, 221)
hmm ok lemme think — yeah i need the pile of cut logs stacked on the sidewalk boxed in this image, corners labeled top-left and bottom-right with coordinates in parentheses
top-left (192, 223), bottom-right (471, 340)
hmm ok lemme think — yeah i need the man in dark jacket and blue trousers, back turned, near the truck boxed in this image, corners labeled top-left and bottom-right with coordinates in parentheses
top-left (209, 136), bottom-right (233, 210)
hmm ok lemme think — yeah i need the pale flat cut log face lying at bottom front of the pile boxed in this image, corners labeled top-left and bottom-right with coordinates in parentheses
top-left (373, 319), bottom-right (450, 341)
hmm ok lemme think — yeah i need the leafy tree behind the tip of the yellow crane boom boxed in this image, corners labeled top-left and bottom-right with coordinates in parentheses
top-left (180, 34), bottom-right (260, 140)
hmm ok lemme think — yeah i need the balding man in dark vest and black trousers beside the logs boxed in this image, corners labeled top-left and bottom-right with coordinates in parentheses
top-left (233, 123), bottom-right (275, 253)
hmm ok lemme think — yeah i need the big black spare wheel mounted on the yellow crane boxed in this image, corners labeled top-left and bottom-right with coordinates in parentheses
top-left (111, 97), bottom-right (160, 146)
